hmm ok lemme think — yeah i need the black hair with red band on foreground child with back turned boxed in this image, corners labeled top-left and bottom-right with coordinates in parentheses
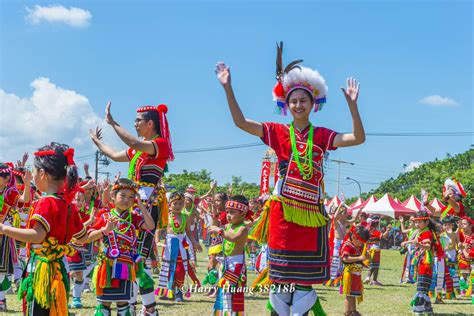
top-left (33, 142), bottom-right (78, 191)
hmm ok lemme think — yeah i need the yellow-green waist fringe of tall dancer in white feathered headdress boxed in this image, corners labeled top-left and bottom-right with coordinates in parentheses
top-left (280, 197), bottom-right (329, 227)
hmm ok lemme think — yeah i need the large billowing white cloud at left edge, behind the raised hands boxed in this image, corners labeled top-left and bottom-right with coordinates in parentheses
top-left (0, 77), bottom-right (120, 162)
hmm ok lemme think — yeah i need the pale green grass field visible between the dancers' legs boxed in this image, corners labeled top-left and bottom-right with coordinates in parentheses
top-left (0, 250), bottom-right (474, 316)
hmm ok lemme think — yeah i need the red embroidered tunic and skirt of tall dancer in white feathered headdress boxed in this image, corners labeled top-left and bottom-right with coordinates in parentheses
top-left (262, 123), bottom-right (337, 284)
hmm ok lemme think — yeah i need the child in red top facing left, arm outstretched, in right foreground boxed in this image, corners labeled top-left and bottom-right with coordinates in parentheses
top-left (402, 211), bottom-right (444, 315)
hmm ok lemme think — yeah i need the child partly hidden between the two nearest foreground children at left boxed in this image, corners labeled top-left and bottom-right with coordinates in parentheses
top-left (67, 188), bottom-right (97, 308)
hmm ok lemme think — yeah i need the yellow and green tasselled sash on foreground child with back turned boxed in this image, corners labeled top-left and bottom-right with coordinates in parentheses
top-left (32, 237), bottom-right (76, 316)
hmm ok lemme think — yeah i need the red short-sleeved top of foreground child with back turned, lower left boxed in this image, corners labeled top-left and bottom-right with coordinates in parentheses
top-left (28, 196), bottom-right (86, 245)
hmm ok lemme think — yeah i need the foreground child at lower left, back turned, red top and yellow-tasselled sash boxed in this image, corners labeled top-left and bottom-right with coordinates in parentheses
top-left (0, 143), bottom-right (86, 316)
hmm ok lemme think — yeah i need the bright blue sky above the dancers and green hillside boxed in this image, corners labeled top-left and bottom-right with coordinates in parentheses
top-left (0, 1), bottom-right (473, 196)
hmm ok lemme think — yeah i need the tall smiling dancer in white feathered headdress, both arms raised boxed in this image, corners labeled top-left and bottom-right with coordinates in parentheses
top-left (216, 40), bottom-right (365, 315)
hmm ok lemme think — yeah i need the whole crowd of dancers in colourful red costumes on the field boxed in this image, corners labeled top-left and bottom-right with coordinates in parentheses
top-left (0, 43), bottom-right (474, 315)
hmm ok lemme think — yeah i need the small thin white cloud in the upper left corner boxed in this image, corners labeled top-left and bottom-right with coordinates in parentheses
top-left (26, 5), bottom-right (92, 27)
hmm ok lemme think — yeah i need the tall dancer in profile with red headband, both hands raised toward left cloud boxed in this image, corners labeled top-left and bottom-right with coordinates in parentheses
top-left (90, 102), bottom-right (174, 315)
